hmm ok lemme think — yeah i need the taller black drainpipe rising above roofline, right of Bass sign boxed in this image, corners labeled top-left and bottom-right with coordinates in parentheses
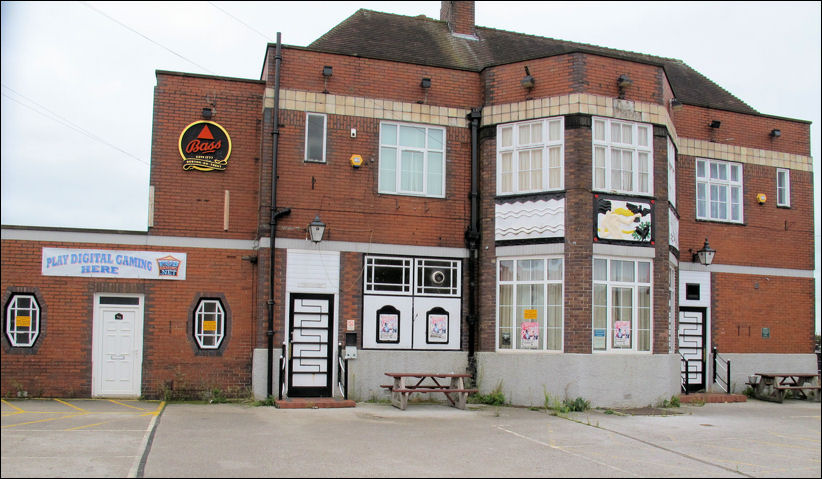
top-left (265, 32), bottom-right (291, 399)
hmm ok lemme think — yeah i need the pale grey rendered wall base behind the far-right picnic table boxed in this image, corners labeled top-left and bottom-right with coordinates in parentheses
top-left (708, 353), bottom-right (819, 394)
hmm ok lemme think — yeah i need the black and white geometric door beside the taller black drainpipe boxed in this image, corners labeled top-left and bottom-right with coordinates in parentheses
top-left (288, 294), bottom-right (334, 397)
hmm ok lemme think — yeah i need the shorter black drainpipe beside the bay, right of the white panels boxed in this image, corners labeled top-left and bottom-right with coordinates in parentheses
top-left (465, 108), bottom-right (482, 382)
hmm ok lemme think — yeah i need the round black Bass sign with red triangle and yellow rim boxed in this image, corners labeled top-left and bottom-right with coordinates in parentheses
top-left (178, 121), bottom-right (231, 171)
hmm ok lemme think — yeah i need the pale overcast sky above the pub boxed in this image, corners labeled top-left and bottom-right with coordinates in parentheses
top-left (0, 1), bottom-right (822, 333)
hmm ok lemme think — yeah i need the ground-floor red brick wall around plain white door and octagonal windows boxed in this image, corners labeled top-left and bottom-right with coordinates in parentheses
top-left (0, 240), bottom-right (254, 398)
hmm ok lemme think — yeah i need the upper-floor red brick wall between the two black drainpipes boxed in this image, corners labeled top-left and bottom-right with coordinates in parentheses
top-left (266, 110), bottom-right (471, 247)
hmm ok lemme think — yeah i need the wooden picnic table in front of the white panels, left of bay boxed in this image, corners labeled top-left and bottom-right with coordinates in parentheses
top-left (380, 373), bottom-right (477, 411)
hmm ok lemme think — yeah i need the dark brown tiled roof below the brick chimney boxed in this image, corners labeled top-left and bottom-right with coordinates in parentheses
top-left (307, 9), bottom-right (758, 114)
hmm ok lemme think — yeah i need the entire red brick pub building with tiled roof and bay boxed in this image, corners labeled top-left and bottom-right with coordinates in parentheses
top-left (2, 2), bottom-right (816, 406)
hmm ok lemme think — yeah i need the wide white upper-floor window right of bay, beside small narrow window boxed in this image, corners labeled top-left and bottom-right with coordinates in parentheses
top-left (696, 158), bottom-right (742, 223)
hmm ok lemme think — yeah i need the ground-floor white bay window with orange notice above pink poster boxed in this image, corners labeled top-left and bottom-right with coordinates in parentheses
top-left (497, 257), bottom-right (564, 351)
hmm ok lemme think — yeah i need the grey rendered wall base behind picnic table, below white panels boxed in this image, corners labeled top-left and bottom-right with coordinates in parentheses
top-left (348, 349), bottom-right (468, 402)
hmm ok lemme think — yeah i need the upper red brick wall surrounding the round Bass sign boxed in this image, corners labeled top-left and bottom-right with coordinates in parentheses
top-left (150, 72), bottom-right (264, 238)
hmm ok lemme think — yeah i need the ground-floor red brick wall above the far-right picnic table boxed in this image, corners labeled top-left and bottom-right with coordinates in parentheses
top-left (711, 273), bottom-right (814, 354)
